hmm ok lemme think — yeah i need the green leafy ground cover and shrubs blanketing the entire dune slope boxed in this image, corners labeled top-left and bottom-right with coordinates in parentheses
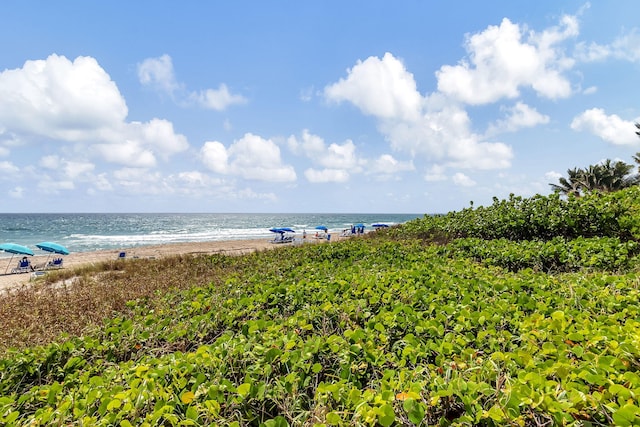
top-left (0, 186), bottom-right (640, 426)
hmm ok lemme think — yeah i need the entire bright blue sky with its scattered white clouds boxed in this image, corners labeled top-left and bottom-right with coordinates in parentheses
top-left (0, 0), bottom-right (640, 214)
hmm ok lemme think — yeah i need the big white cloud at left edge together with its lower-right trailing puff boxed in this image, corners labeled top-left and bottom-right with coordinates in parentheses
top-left (0, 55), bottom-right (189, 167)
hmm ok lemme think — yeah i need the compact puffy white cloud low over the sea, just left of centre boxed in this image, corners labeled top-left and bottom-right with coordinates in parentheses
top-left (200, 133), bottom-right (296, 182)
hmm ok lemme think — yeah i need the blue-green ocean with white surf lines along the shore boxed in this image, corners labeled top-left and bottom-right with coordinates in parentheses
top-left (0, 213), bottom-right (423, 257)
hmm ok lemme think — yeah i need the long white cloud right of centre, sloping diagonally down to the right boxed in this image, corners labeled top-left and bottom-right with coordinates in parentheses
top-left (325, 53), bottom-right (513, 169)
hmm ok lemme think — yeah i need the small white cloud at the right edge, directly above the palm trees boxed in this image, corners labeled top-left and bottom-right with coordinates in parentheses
top-left (571, 108), bottom-right (638, 145)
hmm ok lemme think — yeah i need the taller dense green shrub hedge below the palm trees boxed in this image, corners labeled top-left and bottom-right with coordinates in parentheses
top-left (393, 186), bottom-right (640, 244)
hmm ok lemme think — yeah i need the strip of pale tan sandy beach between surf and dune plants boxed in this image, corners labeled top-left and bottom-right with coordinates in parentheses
top-left (0, 239), bottom-right (324, 290)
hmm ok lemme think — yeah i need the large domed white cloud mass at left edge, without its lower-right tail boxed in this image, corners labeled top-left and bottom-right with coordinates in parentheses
top-left (0, 55), bottom-right (127, 141)
